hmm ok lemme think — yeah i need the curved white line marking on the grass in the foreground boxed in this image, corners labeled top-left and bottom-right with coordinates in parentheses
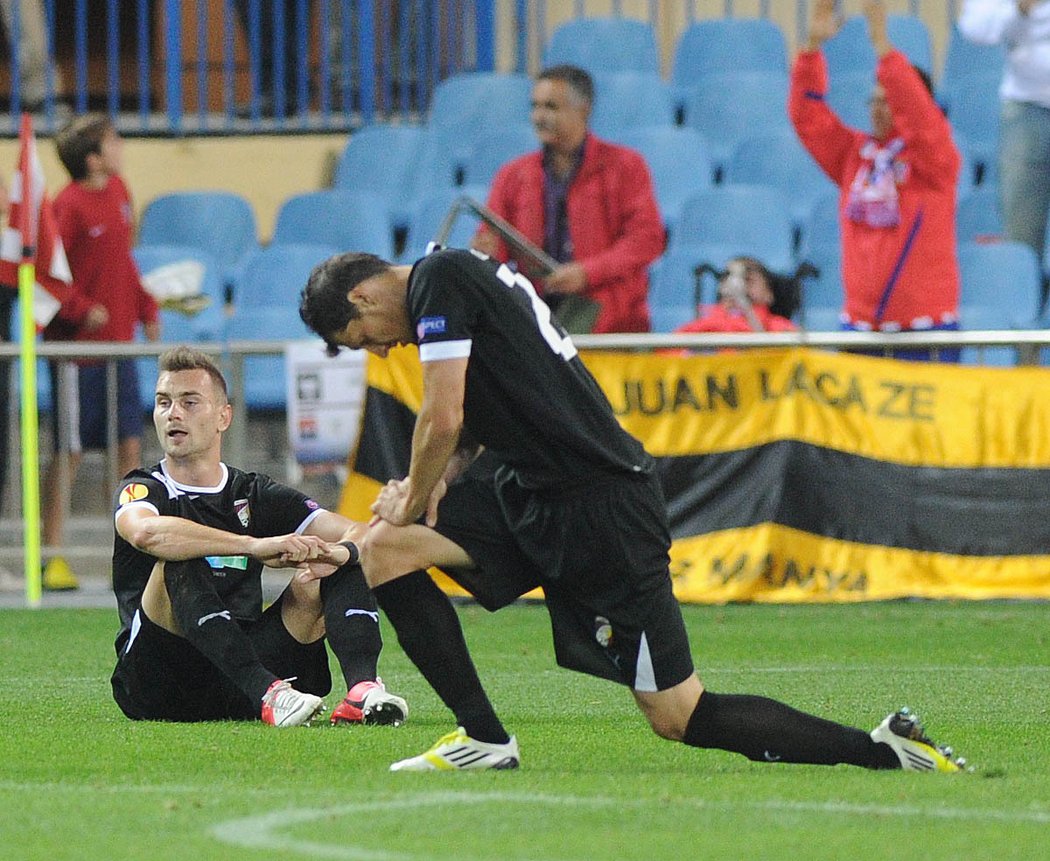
top-left (211, 792), bottom-right (1050, 861)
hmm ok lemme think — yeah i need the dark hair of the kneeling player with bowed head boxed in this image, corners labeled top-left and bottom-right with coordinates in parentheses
top-left (299, 251), bottom-right (391, 356)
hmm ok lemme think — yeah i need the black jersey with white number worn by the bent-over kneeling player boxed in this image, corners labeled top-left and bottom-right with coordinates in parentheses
top-left (407, 249), bottom-right (653, 488)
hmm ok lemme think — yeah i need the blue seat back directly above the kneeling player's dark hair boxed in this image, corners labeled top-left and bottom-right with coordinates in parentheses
top-left (271, 189), bottom-right (394, 260)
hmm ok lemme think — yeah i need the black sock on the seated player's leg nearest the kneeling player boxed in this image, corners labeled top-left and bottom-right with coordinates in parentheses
top-left (321, 565), bottom-right (383, 691)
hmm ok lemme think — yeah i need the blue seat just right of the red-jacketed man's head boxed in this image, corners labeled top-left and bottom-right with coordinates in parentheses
top-left (590, 71), bottom-right (675, 141)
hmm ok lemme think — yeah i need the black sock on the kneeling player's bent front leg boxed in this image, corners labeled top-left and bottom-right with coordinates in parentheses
top-left (373, 571), bottom-right (510, 744)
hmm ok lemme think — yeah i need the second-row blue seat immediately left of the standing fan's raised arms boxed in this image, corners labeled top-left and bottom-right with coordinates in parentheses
top-left (685, 71), bottom-right (792, 176)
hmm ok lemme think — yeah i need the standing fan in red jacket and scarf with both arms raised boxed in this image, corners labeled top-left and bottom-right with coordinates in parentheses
top-left (789, 0), bottom-right (961, 360)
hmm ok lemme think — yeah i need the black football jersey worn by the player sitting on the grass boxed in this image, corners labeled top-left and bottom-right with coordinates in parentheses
top-left (113, 461), bottom-right (323, 631)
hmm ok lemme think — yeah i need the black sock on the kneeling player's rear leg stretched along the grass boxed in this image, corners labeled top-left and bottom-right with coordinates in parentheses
top-left (683, 691), bottom-right (901, 769)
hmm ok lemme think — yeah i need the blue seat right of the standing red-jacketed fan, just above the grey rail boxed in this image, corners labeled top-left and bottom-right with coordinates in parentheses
top-left (959, 242), bottom-right (1042, 329)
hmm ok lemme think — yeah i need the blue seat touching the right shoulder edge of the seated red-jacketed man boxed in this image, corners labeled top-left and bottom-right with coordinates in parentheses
top-left (617, 126), bottom-right (714, 232)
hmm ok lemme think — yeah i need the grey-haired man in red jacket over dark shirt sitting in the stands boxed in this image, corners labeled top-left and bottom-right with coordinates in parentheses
top-left (474, 65), bottom-right (665, 332)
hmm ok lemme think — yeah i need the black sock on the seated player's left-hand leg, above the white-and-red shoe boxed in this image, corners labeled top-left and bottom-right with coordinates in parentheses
top-left (164, 559), bottom-right (277, 702)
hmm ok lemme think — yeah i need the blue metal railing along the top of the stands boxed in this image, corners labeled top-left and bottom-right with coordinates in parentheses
top-left (0, 0), bottom-right (959, 135)
